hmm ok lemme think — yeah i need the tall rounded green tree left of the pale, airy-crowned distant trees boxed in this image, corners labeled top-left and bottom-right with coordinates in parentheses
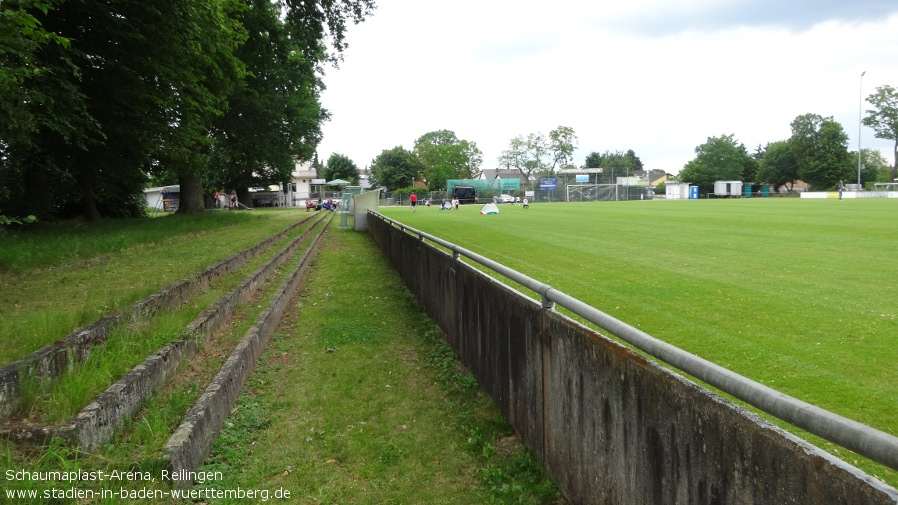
top-left (414, 130), bottom-right (483, 190)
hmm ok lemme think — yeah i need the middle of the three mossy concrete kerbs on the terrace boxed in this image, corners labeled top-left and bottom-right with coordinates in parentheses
top-left (28, 215), bottom-right (328, 452)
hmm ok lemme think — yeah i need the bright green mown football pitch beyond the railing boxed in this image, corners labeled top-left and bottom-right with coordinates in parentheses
top-left (381, 198), bottom-right (898, 486)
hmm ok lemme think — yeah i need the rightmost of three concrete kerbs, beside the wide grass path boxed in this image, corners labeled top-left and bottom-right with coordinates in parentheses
top-left (163, 222), bottom-right (330, 487)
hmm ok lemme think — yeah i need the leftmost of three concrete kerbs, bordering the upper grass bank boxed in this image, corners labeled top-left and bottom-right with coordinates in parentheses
top-left (0, 216), bottom-right (314, 420)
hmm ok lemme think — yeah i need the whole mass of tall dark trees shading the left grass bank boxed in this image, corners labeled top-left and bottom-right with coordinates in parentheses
top-left (0, 0), bottom-right (375, 220)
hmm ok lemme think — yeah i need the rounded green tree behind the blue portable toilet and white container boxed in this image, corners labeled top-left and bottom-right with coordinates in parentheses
top-left (679, 135), bottom-right (754, 193)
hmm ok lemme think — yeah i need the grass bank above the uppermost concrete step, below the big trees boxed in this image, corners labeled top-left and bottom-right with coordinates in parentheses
top-left (0, 211), bottom-right (306, 365)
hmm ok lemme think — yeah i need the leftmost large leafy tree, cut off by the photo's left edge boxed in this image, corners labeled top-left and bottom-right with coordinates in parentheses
top-left (0, 0), bottom-right (99, 218)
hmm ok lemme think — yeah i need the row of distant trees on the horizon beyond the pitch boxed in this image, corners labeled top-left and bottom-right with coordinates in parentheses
top-left (288, 86), bottom-right (898, 196)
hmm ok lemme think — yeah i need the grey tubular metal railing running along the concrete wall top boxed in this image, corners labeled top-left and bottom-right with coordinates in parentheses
top-left (369, 211), bottom-right (898, 470)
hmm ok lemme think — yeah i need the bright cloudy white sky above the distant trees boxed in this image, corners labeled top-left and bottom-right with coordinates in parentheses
top-left (318, 0), bottom-right (898, 174)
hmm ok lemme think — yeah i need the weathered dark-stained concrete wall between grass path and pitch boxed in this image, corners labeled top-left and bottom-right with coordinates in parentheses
top-left (368, 217), bottom-right (898, 505)
